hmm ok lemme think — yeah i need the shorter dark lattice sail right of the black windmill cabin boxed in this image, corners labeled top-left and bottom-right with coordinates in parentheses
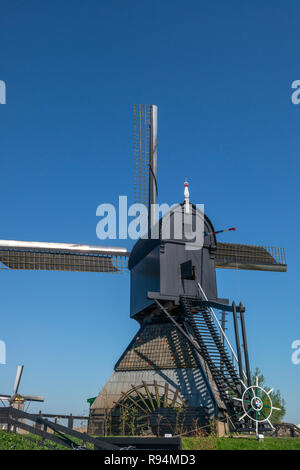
top-left (215, 242), bottom-right (287, 272)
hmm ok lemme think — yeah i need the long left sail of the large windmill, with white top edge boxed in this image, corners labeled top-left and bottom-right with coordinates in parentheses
top-left (0, 240), bottom-right (129, 273)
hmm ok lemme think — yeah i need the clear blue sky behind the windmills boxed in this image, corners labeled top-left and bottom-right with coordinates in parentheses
top-left (0, 0), bottom-right (300, 423)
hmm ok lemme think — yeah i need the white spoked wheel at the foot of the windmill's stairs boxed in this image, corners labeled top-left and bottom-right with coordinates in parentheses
top-left (234, 377), bottom-right (280, 434)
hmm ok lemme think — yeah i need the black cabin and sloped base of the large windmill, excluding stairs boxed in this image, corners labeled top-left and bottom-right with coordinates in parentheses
top-left (89, 204), bottom-right (223, 434)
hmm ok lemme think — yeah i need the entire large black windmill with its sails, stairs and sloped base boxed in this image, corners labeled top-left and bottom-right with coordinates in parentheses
top-left (0, 105), bottom-right (287, 434)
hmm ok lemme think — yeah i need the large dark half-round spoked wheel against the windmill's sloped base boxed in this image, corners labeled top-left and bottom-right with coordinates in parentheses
top-left (116, 381), bottom-right (186, 435)
